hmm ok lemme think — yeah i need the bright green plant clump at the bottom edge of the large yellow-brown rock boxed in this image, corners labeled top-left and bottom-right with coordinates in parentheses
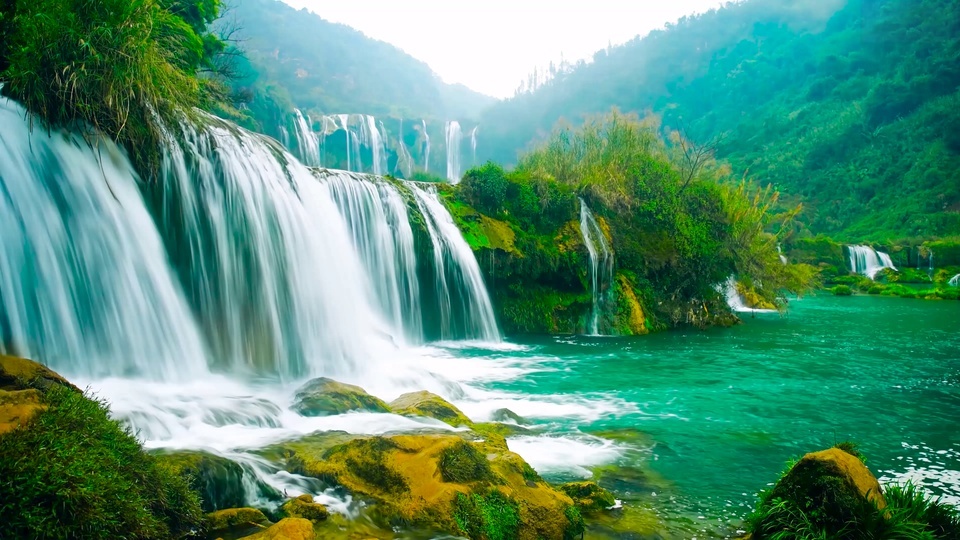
top-left (453, 489), bottom-right (520, 540)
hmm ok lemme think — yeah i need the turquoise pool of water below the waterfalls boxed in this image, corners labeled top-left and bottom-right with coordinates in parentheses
top-left (456, 296), bottom-right (960, 537)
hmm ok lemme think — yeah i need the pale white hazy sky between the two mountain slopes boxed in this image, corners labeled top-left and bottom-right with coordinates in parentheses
top-left (284, 0), bottom-right (720, 97)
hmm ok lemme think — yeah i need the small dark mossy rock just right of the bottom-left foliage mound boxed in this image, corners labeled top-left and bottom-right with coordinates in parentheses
top-left (155, 451), bottom-right (245, 512)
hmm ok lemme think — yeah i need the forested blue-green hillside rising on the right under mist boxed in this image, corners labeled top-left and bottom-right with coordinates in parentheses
top-left (481, 0), bottom-right (960, 240)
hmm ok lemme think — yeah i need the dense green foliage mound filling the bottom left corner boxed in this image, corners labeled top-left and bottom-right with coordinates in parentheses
top-left (0, 386), bottom-right (203, 539)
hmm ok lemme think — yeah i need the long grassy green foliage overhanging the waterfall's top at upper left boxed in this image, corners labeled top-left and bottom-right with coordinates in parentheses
top-left (0, 0), bottom-right (221, 168)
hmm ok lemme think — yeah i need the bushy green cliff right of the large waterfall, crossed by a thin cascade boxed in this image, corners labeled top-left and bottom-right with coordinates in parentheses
top-left (446, 113), bottom-right (814, 335)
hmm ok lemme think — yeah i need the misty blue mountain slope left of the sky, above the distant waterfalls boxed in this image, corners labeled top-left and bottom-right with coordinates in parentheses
top-left (223, 0), bottom-right (494, 119)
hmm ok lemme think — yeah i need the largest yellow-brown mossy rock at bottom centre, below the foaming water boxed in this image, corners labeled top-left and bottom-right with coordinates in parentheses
top-left (287, 432), bottom-right (583, 540)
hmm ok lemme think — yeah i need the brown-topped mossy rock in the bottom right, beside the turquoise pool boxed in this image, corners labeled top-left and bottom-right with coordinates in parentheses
top-left (750, 448), bottom-right (886, 538)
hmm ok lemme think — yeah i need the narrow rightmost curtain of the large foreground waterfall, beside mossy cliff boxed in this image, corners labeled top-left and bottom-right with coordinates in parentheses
top-left (409, 183), bottom-right (501, 341)
